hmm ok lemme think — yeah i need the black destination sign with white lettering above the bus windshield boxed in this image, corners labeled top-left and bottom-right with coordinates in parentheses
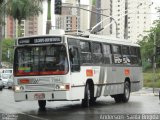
top-left (18, 37), bottom-right (61, 45)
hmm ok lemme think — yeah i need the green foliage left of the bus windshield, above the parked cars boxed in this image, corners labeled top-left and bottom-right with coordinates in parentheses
top-left (1, 39), bottom-right (15, 63)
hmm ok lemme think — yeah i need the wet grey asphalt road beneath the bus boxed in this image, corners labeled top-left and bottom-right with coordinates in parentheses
top-left (0, 89), bottom-right (160, 120)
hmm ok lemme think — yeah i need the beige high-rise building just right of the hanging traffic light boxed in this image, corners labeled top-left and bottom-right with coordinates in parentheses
top-left (62, 0), bottom-right (92, 31)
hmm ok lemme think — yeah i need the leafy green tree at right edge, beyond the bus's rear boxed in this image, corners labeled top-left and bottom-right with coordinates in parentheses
top-left (139, 9), bottom-right (160, 69)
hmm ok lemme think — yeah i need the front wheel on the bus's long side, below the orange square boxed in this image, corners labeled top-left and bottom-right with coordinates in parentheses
top-left (82, 83), bottom-right (91, 107)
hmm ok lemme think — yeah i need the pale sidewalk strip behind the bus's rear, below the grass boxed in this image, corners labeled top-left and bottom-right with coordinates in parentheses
top-left (131, 87), bottom-right (160, 96)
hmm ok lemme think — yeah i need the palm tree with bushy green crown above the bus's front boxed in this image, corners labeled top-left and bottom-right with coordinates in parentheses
top-left (6, 0), bottom-right (42, 36)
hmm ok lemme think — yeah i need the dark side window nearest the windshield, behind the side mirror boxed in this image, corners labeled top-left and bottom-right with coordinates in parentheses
top-left (69, 47), bottom-right (80, 72)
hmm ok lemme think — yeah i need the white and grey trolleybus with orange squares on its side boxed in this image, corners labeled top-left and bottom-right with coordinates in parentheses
top-left (14, 31), bottom-right (143, 109)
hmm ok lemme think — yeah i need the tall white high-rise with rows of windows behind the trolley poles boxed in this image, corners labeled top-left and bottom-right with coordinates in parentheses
top-left (97, 0), bottom-right (152, 42)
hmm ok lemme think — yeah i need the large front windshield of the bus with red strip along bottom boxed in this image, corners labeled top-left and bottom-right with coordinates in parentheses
top-left (14, 45), bottom-right (68, 76)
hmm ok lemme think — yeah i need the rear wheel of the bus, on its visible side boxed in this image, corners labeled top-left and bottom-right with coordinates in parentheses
top-left (122, 81), bottom-right (130, 102)
